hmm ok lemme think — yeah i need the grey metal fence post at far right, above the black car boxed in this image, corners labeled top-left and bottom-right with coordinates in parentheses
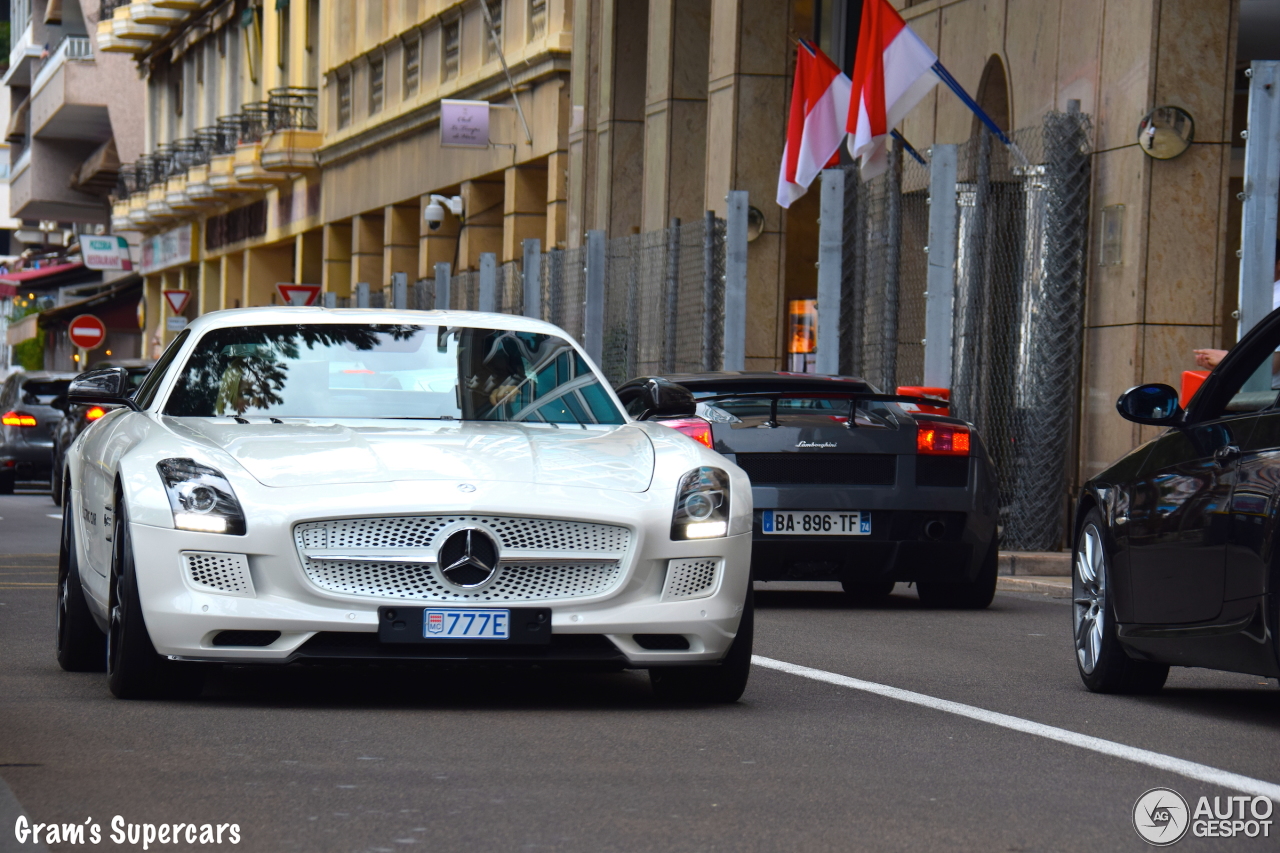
top-left (1236, 60), bottom-right (1280, 376)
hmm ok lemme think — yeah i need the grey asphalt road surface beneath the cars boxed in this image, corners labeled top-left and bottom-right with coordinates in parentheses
top-left (0, 484), bottom-right (1280, 853)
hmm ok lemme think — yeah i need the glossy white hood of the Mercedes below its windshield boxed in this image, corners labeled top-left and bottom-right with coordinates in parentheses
top-left (166, 418), bottom-right (654, 492)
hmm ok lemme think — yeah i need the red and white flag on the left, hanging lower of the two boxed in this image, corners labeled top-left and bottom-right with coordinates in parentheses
top-left (778, 41), bottom-right (850, 207)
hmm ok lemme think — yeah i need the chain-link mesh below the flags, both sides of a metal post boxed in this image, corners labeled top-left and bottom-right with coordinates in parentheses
top-left (840, 113), bottom-right (1091, 549)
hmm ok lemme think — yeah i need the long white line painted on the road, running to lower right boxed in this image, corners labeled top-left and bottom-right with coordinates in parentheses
top-left (751, 654), bottom-right (1280, 803)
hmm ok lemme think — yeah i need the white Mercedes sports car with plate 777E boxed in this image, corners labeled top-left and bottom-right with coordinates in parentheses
top-left (58, 307), bottom-right (753, 702)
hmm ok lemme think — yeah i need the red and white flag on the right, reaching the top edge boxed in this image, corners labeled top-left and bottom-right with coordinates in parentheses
top-left (846, 0), bottom-right (941, 181)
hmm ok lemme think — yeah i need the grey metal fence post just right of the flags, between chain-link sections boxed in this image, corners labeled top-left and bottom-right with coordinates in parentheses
top-left (926, 145), bottom-right (957, 388)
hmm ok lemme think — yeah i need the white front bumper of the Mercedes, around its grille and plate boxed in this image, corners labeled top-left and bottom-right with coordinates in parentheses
top-left (131, 516), bottom-right (751, 667)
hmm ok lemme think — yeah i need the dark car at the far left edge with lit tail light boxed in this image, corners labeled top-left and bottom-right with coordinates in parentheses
top-left (0, 371), bottom-right (76, 494)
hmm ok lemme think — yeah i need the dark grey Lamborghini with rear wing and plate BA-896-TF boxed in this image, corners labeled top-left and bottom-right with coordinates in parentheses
top-left (617, 373), bottom-right (998, 608)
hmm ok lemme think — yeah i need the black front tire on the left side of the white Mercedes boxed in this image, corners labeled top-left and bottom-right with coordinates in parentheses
top-left (106, 494), bottom-right (205, 699)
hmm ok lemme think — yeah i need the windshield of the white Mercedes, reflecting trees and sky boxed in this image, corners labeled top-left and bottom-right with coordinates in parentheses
top-left (164, 323), bottom-right (626, 424)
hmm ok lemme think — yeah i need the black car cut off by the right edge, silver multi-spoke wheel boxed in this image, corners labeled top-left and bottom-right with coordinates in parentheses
top-left (1073, 311), bottom-right (1280, 693)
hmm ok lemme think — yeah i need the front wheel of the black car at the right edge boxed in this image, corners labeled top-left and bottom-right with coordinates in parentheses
top-left (1071, 507), bottom-right (1169, 694)
